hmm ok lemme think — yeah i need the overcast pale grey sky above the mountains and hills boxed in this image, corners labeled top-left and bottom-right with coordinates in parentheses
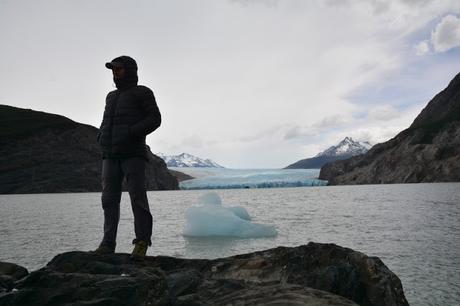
top-left (0, 0), bottom-right (460, 168)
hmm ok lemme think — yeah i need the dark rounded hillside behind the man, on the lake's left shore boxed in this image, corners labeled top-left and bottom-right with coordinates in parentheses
top-left (0, 105), bottom-right (179, 194)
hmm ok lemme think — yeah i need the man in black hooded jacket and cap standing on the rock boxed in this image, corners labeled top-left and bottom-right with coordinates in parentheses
top-left (95, 56), bottom-right (161, 256)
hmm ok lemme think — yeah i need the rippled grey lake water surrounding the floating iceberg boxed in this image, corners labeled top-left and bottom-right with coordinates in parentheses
top-left (0, 183), bottom-right (460, 305)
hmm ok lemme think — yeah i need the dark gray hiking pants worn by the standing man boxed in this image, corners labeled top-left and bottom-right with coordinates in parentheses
top-left (101, 157), bottom-right (152, 247)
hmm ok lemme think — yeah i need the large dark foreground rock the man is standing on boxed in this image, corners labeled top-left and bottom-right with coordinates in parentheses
top-left (0, 242), bottom-right (408, 305)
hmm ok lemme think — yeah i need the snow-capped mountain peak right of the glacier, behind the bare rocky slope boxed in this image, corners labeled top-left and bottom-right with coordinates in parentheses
top-left (286, 137), bottom-right (372, 169)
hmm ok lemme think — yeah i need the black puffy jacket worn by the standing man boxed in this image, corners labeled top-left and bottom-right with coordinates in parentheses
top-left (97, 85), bottom-right (161, 158)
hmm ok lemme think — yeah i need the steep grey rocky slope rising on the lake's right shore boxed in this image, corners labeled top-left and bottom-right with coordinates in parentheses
top-left (319, 74), bottom-right (460, 185)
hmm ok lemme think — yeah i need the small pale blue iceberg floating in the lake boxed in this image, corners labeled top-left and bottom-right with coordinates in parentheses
top-left (183, 192), bottom-right (278, 238)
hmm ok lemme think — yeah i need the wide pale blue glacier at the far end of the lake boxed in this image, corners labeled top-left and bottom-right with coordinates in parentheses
top-left (175, 168), bottom-right (327, 189)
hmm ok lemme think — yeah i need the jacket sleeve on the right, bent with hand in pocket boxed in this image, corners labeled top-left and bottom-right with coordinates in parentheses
top-left (129, 88), bottom-right (161, 136)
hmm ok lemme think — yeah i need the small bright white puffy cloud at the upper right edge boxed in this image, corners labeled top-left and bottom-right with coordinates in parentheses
top-left (431, 15), bottom-right (460, 52)
